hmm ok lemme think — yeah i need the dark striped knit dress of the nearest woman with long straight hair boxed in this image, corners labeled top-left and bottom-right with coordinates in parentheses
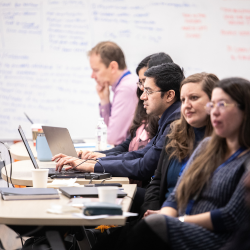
top-left (164, 138), bottom-right (250, 249)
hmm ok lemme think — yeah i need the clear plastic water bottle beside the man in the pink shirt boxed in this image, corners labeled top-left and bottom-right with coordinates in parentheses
top-left (96, 117), bottom-right (107, 151)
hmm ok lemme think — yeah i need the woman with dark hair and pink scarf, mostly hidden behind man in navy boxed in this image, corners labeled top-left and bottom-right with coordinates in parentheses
top-left (78, 52), bottom-right (173, 159)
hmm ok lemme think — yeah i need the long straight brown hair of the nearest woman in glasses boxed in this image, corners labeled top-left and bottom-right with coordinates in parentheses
top-left (176, 77), bottom-right (250, 210)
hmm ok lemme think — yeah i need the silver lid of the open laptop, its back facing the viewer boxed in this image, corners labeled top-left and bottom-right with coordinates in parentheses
top-left (42, 126), bottom-right (78, 157)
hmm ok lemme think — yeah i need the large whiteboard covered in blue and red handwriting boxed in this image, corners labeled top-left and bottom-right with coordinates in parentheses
top-left (0, 0), bottom-right (250, 140)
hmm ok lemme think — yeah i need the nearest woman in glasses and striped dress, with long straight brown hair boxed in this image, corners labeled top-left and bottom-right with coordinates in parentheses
top-left (93, 78), bottom-right (250, 250)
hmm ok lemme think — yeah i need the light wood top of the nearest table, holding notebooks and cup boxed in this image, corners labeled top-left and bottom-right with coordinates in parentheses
top-left (0, 184), bottom-right (136, 226)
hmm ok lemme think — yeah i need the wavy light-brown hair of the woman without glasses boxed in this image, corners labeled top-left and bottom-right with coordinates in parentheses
top-left (166, 72), bottom-right (219, 162)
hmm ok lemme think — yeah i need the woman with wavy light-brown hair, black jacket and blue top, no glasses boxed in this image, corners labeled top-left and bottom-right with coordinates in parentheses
top-left (141, 73), bottom-right (219, 215)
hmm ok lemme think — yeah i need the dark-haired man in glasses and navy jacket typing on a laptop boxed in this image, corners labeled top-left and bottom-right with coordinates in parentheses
top-left (52, 63), bottom-right (184, 181)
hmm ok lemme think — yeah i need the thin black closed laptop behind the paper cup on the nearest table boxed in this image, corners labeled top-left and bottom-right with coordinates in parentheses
top-left (59, 187), bottom-right (127, 198)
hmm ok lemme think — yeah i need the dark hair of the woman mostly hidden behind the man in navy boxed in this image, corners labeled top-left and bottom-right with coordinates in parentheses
top-left (130, 52), bottom-right (173, 138)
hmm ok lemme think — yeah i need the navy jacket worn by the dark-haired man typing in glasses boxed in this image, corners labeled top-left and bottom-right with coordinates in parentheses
top-left (94, 101), bottom-right (181, 181)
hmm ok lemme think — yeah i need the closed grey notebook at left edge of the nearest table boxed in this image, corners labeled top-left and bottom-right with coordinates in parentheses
top-left (0, 188), bottom-right (60, 201)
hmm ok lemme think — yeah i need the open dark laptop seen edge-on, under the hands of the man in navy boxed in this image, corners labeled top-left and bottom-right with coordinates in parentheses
top-left (18, 126), bottom-right (85, 178)
